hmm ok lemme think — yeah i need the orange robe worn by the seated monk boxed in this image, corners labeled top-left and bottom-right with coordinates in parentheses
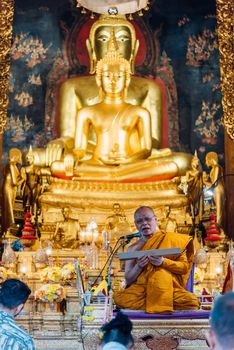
top-left (114, 231), bottom-right (199, 313)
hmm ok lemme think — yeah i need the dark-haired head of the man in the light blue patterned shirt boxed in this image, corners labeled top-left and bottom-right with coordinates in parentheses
top-left (0, 278), bottom-right (31, 317)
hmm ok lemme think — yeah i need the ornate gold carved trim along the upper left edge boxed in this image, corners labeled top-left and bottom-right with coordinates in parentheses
top-left (0, 0), bottom-right (14, 134)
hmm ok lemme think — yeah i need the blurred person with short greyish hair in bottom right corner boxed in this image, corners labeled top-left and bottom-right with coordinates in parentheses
top-left (206, 292), bottom-right (234, 350)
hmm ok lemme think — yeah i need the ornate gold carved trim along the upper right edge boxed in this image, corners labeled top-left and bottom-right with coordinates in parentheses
top-left (216, 0), bottom-right (234, 140)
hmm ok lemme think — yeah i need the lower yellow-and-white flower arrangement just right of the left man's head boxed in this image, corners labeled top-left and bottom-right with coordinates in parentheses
top-left (35, 284), bottom-right (65, 303)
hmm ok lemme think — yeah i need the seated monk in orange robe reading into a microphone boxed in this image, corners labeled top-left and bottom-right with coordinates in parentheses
top-left (114, 206), bottom-right (199, 313)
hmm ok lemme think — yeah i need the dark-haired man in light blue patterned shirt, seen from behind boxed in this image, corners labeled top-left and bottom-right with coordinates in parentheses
top-left (0, 278), bottom-right (35, 350)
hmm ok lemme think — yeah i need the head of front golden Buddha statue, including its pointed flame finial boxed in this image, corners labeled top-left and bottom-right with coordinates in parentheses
top-left (96, 34), bottom-right (131, 96)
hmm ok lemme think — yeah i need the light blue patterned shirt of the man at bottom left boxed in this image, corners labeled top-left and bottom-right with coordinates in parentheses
top-left (0, 311), bottom-right (35, 350)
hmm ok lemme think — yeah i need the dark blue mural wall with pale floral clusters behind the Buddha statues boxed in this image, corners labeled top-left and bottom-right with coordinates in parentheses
top-left (3, 0), bottom-right (224, 170)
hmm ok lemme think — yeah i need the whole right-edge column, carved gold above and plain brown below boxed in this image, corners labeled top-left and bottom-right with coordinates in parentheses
top-left (216, 0), bottom-right (234, 240)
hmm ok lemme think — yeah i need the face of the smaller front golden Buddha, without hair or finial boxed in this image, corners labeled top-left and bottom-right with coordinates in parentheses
top-left (101, 64), bottom-right (126, 94)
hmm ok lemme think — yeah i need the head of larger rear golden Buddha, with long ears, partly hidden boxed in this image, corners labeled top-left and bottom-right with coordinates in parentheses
top-left (86, 15), bottom-right (139, 74)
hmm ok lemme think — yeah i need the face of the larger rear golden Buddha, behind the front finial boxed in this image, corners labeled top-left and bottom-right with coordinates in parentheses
top-left (94, 25), bottom-right (133, 60)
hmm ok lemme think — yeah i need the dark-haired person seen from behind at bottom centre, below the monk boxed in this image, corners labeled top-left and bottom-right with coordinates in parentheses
top-left (99, 312), bottom-right (134, 350)
